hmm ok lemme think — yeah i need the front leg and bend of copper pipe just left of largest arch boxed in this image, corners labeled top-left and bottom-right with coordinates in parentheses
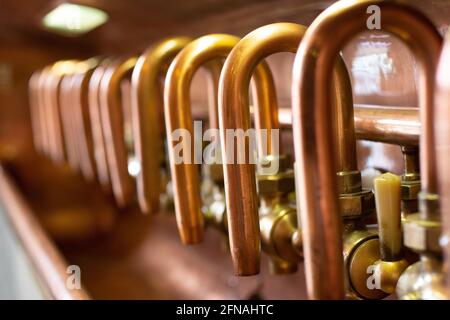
top-left (219, 23), bottom-right (298, 276)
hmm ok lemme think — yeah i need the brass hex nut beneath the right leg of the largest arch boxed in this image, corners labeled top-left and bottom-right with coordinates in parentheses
top-left (403, 213), bottom-right (441, 254)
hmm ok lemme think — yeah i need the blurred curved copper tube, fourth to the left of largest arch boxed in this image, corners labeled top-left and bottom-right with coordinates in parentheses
top-left (100, 57), bottom-right (137, 207)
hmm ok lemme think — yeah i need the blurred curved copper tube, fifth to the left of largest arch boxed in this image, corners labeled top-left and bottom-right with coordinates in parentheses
top-left (88, 60), bottom-right (112, 193)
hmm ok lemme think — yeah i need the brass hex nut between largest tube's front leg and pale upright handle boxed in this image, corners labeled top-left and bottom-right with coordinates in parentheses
top-left (339, 190), bottom-right (375, 218)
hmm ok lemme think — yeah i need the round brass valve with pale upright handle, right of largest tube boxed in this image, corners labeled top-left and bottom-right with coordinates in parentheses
top-left (344, 173), bottom-right (408, 299)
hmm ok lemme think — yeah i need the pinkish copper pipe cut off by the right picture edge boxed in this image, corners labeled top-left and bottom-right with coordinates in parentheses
top-left (434, 32), bottom-right (450, 296)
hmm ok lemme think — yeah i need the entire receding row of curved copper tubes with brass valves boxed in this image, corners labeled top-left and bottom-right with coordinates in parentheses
top-left (30, 0), bottom-right (450, 299)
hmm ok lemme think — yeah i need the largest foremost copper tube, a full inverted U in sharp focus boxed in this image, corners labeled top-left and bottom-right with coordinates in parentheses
top-left (292, 0), bottom-right (441, 299)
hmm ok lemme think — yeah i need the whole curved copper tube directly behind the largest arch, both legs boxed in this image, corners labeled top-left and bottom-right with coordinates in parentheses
top-left (219, 23), bottom-right (357, 275)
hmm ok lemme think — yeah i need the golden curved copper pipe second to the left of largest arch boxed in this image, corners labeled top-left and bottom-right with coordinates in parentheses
top-left (164, 34), bottom-right (275, 244)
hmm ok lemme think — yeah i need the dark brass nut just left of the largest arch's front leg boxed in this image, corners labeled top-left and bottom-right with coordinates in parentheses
top-left (258, 170), bottom-right (295, 195)
